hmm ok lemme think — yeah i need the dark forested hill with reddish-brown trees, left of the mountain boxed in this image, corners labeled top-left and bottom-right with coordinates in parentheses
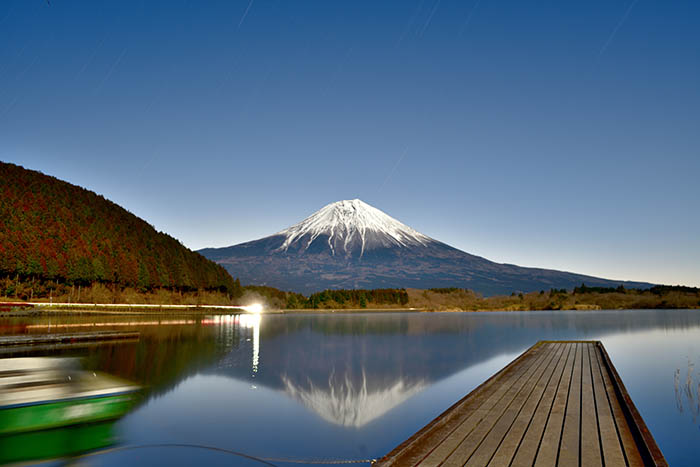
top-left (0, 162), bottom-right (237, 291)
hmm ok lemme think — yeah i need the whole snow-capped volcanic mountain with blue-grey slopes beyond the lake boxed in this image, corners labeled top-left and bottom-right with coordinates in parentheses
top-left (199, 199), bottom-right (652, 295)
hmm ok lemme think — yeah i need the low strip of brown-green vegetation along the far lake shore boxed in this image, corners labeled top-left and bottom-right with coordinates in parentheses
top-left (0, 277), bottom-right (700, 311)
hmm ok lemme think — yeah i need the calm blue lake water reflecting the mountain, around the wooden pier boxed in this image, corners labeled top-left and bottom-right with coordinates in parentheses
top-left (0, 310), bottom-right (700, 466)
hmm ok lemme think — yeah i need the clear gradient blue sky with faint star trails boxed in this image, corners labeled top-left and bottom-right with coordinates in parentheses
top-left (0, 0), bottom-right (700, 286)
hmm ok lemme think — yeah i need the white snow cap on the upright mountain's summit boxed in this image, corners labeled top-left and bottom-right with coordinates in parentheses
top-left (276, 199), bottom-right (432, 256)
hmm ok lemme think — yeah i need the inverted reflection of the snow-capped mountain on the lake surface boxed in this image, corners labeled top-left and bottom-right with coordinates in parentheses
top-left (206, 312), bottom-right (700, 434)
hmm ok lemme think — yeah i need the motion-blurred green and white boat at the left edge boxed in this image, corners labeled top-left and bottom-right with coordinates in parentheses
top-left (0, 358), bottom-right (139, 437)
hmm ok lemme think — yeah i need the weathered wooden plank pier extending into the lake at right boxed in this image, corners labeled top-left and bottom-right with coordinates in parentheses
top-left (377, 341), bottom-right (668, 467)
